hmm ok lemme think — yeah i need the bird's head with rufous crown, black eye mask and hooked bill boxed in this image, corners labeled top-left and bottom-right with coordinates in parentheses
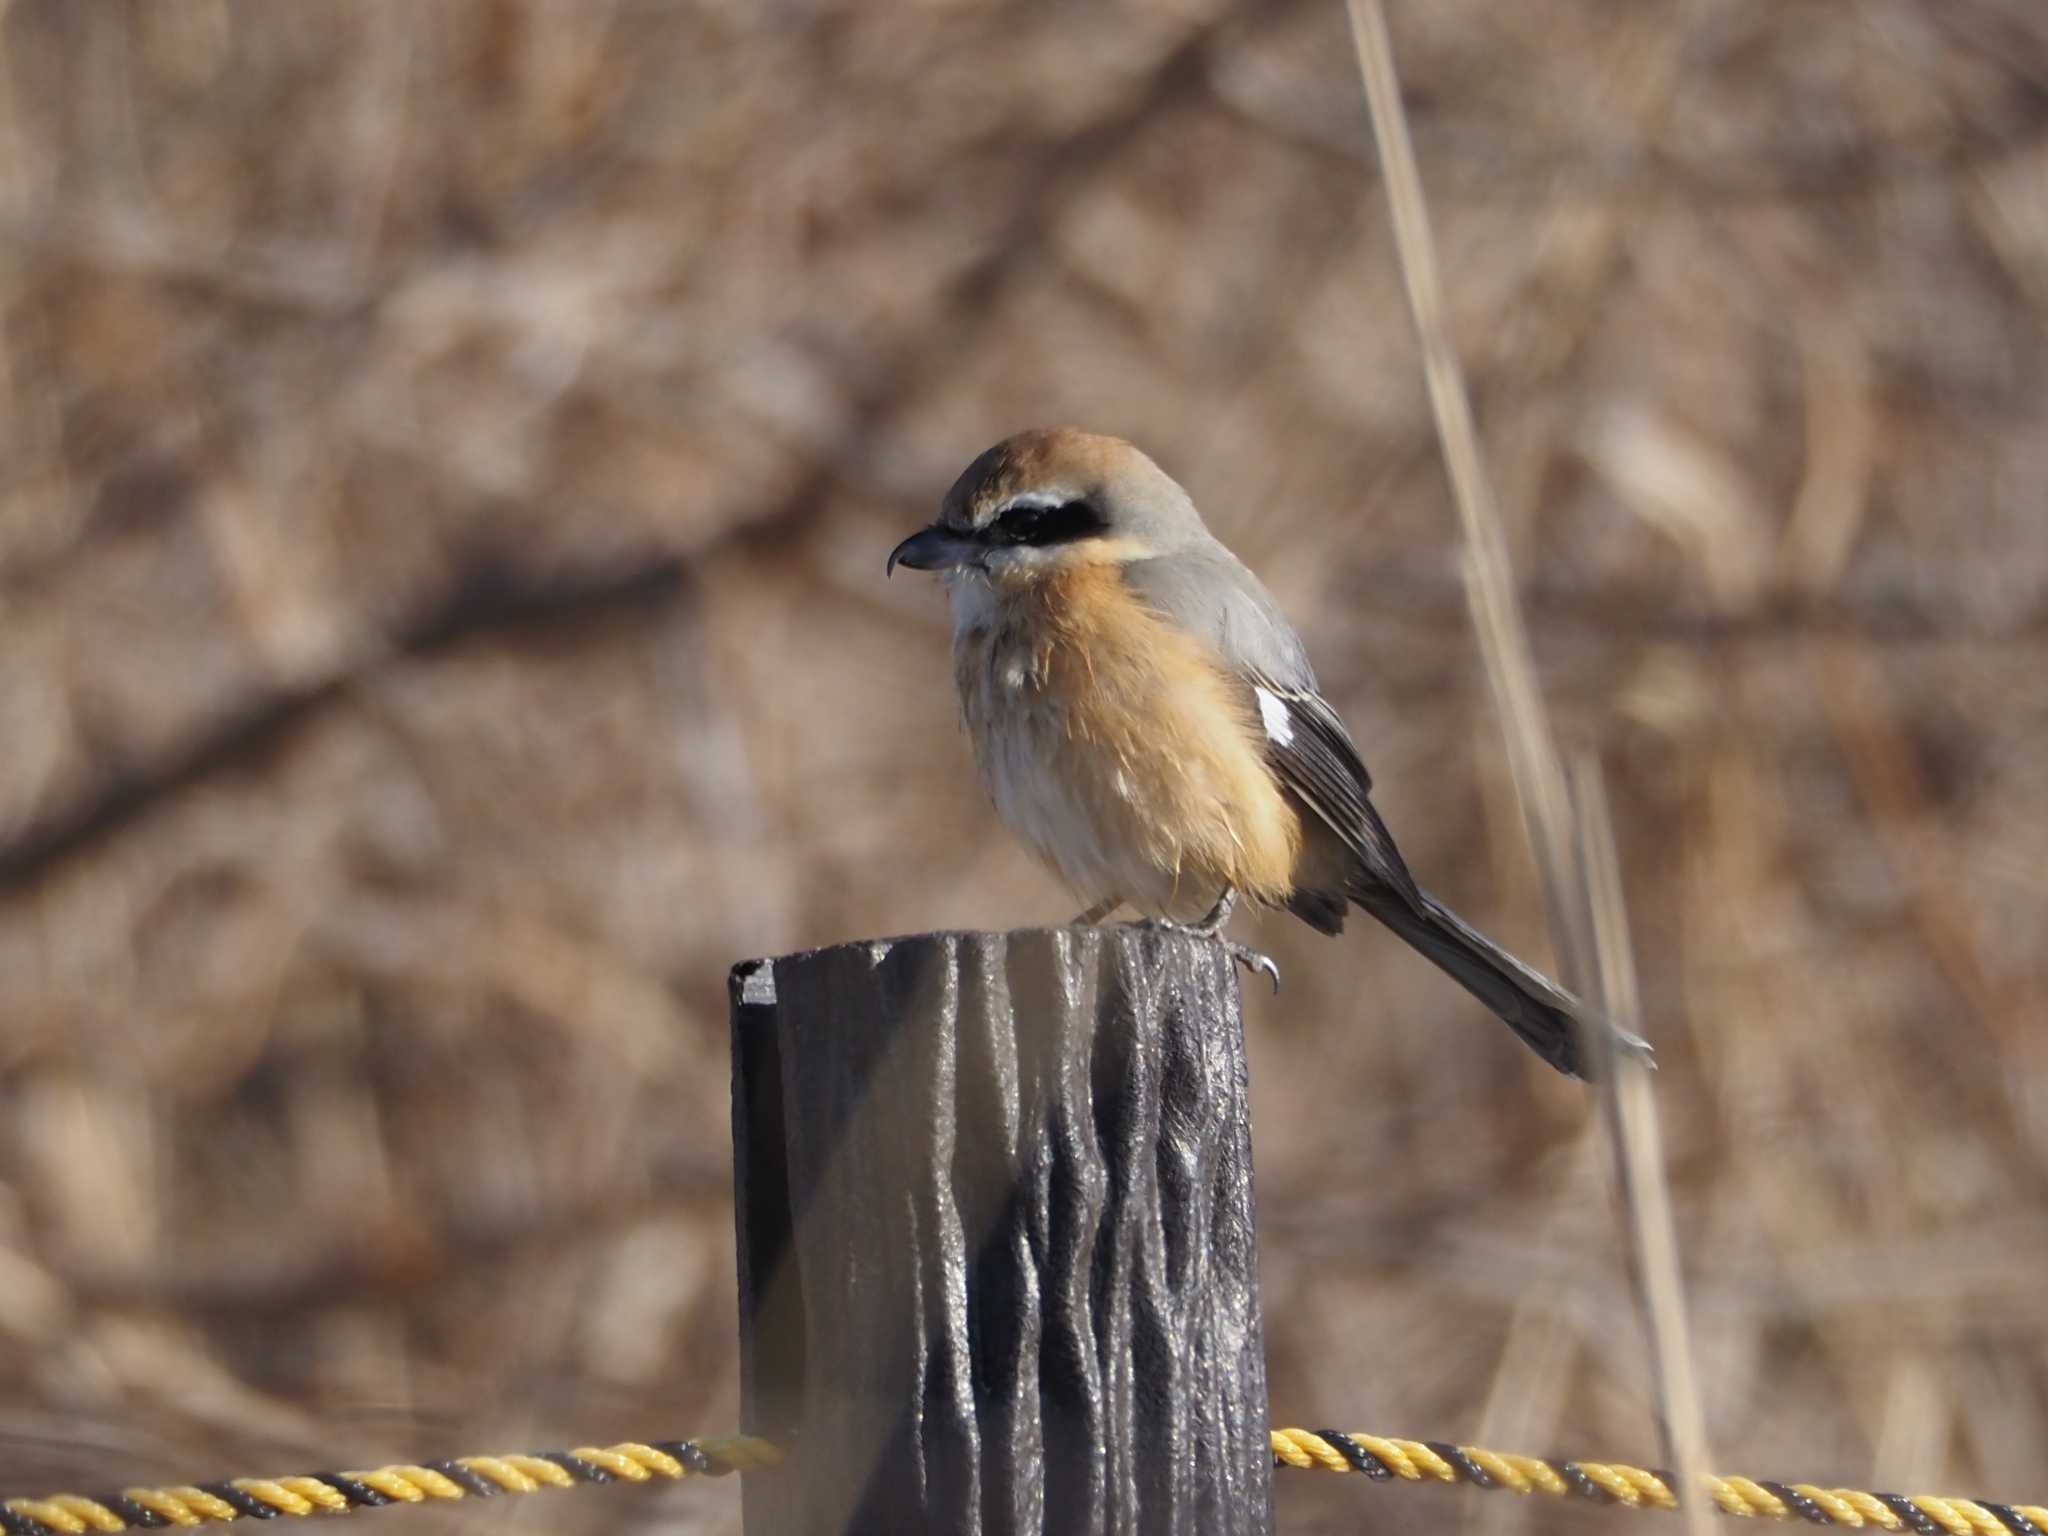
top-left (889, 428), bottom-right (1208, 588)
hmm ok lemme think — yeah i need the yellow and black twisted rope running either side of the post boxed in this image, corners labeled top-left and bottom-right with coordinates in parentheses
top-left (0, 1430), bottom-right (2048, 1536)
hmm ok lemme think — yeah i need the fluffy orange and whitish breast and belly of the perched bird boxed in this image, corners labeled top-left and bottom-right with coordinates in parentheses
top-left (954, 561), bottom-right (1303, 911)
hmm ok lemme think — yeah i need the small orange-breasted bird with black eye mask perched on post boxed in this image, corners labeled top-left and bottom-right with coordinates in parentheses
top-left (885, 428), bottom-right (1647, 1077)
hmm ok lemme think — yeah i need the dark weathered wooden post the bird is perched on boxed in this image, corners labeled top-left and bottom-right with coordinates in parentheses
top-left (731, 928), bottom-right (1272, 1536)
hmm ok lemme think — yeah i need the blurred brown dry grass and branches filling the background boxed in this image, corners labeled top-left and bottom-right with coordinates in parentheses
top-left (0, 0), bottom-right (2048, 1534)
